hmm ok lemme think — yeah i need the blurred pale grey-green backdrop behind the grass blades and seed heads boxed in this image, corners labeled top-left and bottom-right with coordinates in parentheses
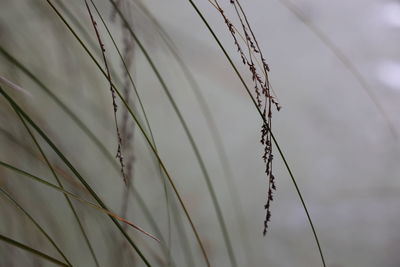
top-left (0, 0), bottom-right (400, 267)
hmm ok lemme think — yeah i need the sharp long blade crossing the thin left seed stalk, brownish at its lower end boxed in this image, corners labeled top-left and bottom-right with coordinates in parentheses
top-left (46, 0), bottom-right (210, 266)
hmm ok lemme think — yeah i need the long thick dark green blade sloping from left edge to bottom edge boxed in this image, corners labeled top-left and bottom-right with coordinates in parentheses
top-left (0, 87), bottom-right (151, 266)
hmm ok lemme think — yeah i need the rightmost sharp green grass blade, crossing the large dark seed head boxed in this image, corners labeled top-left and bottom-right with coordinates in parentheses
top-left (188, 0), bottom-right (326, 267)
